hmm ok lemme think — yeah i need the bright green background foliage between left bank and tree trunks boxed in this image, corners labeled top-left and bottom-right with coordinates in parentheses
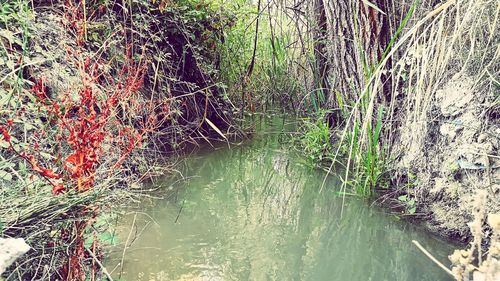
top-left (220, 0), bottom-right (304, 108)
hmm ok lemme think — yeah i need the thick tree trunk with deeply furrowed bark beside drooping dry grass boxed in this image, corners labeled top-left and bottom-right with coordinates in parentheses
top-left (322, 0), bottom-right (396, 126)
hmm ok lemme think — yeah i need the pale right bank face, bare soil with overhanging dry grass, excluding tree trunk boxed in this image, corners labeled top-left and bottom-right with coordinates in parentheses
top-left (368, 1), bottom-right (500, 243)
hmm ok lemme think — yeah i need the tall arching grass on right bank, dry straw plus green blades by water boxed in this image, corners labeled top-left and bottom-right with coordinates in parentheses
top-left (316, 1), bottom-right (499, 200)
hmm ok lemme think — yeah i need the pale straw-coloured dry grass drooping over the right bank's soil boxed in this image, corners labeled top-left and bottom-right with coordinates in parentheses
top-left (388, 1), bottom-right (500, 165)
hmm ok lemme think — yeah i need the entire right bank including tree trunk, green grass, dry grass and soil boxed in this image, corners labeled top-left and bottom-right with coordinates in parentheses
top-left (296, 0), bottom-right (500, 243)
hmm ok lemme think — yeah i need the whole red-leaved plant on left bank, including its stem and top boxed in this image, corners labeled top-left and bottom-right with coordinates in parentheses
top-left (4, 0), bottom-right (170, 280)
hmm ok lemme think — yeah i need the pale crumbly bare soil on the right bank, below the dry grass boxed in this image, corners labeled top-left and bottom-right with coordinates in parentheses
top-left (397, 74), bottom-right (500, 242)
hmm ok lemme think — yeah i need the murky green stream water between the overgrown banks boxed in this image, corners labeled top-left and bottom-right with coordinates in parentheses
top-left (106, 114), bottom-right (453, 281)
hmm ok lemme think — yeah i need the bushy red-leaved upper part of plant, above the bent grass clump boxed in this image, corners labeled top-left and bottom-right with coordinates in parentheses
top-left (32, 47), bottom-right (146, 195)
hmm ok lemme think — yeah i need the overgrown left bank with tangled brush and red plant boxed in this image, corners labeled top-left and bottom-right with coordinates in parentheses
top-left (0, 0), bottom-right (238, 280)
